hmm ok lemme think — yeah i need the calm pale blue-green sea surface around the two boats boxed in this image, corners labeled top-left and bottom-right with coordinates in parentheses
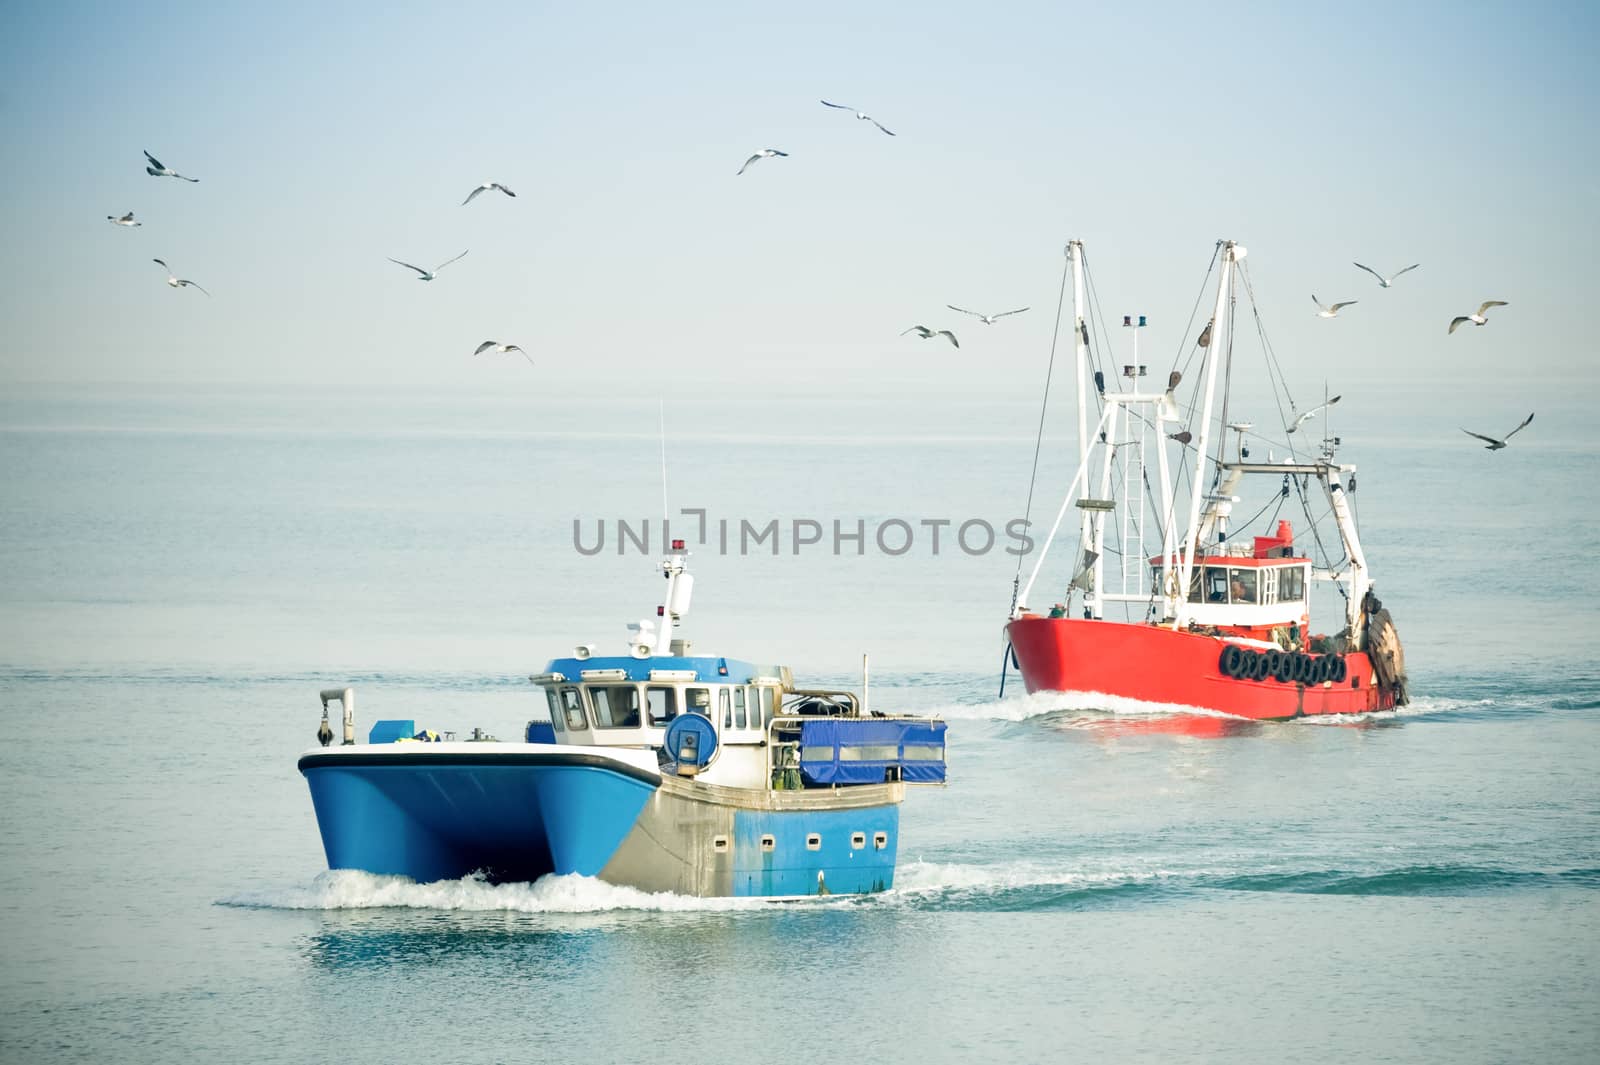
top-left (0, 382), bottom-right (1600, 1065)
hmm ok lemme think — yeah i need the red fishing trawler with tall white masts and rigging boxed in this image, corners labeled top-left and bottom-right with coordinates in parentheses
top-left (1002, 241), bottom-right (1406, 720)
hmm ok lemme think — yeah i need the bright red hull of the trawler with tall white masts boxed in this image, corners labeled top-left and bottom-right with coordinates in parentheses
top-left (1006, 616), bottom-right (1395, 721)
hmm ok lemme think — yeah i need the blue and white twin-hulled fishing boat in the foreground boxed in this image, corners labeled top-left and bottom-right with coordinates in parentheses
top-left (299, 540), bottom-right (946, 899)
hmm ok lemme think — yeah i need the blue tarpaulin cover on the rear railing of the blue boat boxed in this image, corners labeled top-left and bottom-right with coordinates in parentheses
top-left (800, 718), bottom-right (944, 787)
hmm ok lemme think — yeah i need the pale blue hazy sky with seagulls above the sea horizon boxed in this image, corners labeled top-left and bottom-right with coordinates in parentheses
top-left (0, 0), bottom-right (1600, 398)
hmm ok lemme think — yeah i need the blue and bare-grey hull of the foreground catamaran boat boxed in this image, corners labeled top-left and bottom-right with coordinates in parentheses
top-left (299, 744), bottom-right (904, 897)
